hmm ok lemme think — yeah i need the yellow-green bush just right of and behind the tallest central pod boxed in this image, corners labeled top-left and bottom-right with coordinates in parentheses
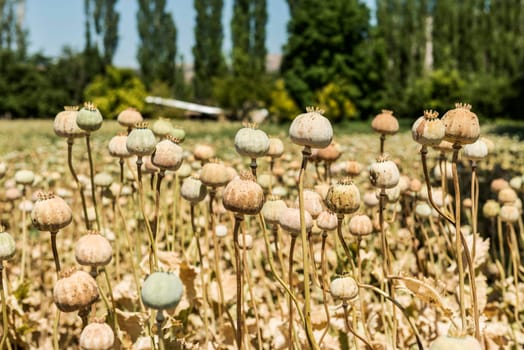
top-left (316, 83), bottom-right (357, 122)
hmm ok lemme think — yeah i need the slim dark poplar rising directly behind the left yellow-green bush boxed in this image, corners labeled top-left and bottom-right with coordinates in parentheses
top-left (93, 0), bottom-right (120, 66)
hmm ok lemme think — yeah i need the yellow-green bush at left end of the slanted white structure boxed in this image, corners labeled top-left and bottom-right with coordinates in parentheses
top-left (84, 66), bottom-right (147, 119)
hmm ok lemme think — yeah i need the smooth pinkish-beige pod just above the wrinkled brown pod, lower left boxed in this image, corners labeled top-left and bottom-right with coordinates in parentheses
top-left (75, 230), bottom-right (113, 266)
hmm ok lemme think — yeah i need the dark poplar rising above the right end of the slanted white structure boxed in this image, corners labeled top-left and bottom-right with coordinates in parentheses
top-left (193, 0), bottom-right (225, 101)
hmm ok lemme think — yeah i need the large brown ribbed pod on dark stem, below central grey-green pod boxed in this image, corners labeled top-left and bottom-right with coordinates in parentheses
top-left (222, 172), bottom-right (264, 215)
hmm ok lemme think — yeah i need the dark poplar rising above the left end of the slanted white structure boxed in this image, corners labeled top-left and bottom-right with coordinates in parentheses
top-left (137, 0), bottom-right (177, 88)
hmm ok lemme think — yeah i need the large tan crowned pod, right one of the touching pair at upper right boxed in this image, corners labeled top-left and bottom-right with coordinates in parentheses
top-left (442, 103), bottom-right (480, 145)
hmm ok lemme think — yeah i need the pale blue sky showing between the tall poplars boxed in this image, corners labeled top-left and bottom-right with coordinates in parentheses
top-left (25, 0), bottom-right (289, 67)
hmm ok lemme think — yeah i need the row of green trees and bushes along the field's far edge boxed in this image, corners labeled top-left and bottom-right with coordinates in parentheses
top-left (0, 0), bottom-right (524, 121)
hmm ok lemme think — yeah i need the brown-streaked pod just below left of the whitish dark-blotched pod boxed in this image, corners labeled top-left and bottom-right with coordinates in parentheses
top-left (326, 177), bottom-right (360, 214)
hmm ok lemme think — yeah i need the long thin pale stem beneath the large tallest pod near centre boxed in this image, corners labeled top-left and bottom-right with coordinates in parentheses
top-left (298, 146), bottom-right (319, 350)
